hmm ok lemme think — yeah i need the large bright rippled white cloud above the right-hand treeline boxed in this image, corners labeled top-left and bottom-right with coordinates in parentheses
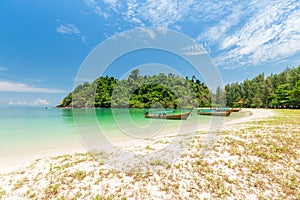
top-left (198, 0), bottom-right (300, 68)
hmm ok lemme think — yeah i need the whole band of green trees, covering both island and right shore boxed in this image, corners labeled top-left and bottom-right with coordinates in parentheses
top-left (58, 66), bottom-right (300, 108)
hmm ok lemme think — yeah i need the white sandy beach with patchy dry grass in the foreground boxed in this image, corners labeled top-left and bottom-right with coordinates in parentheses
top-left (0, 109), bottom-right (300, 199)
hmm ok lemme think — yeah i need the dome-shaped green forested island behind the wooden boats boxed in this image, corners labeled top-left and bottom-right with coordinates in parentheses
top-left (59, 70), bottom-right (211, 108)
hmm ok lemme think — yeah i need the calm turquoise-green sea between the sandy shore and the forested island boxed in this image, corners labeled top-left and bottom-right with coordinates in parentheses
top-left (0, 107), bottom-right (244, 167)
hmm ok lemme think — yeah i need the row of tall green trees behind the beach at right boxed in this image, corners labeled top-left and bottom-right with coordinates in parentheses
top-left (225, 66), bottom-right (300, 108)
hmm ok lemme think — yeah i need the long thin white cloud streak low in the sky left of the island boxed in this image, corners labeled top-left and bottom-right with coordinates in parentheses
top-left (0, 81), bottom-right (65, 93)
